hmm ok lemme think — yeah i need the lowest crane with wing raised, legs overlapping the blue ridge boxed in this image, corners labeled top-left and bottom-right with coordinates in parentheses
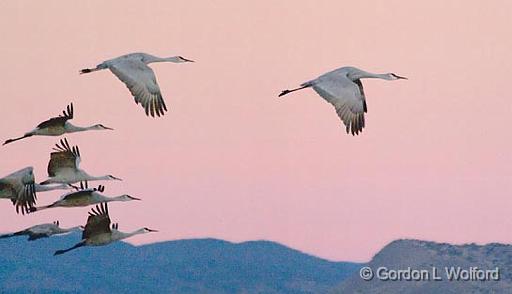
top-left (54, 203), bottom-right (157, 255)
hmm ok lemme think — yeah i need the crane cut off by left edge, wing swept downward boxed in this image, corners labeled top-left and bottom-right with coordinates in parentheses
top-left (0, 167), bottom-right (70, 214)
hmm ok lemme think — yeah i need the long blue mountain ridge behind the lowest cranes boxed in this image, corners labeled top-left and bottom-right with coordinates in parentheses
top-left (0, 233), bottom-right (359, 294)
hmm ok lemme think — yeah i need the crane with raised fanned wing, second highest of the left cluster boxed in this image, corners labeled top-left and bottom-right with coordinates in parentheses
top-left (41, 138), bottom-right (121, 185)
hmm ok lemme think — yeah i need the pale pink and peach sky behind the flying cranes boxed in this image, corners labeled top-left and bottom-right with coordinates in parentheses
top-left (0, 0), bottom-right (512, 261)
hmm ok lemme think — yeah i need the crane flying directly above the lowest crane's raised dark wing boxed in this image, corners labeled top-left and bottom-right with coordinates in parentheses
top-left (30, 182), bottom-right (140, 212)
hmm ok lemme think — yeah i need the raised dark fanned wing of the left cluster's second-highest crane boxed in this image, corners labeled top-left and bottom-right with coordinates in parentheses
top-left (48, 138), bottom-right (80, 177)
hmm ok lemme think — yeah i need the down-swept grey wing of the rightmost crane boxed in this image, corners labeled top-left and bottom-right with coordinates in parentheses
top-left (313, 76), bottom-right (367, 135)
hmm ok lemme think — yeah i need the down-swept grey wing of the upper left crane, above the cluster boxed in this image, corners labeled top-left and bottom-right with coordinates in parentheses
top-left (109, 59), bottom-right (167, 117)
